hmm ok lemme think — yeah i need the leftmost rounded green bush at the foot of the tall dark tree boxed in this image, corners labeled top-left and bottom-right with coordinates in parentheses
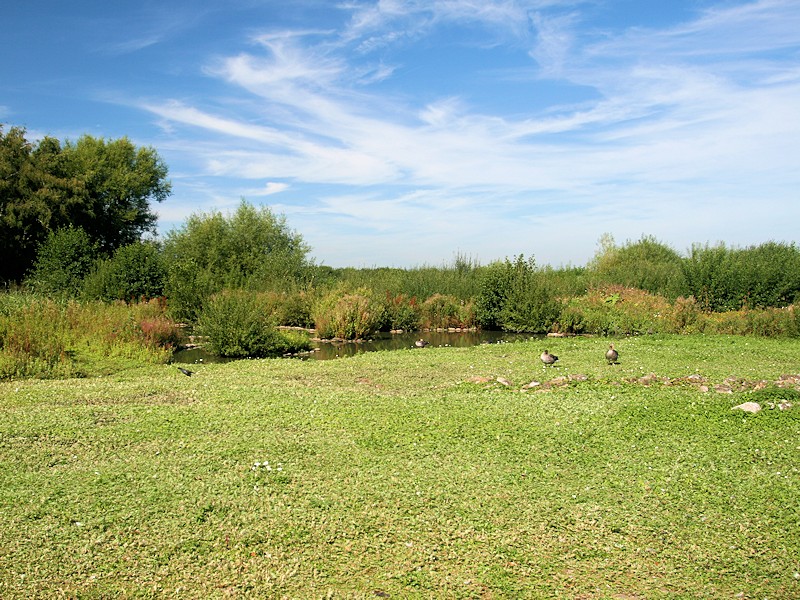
top-left (27, 227), bottom-right (97, 297)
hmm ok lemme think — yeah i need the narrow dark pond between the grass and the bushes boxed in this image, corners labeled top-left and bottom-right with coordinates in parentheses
top-left (172, 331), bottom-right (544, 364)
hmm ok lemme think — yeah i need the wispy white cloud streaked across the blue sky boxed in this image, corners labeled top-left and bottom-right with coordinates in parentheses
top-left (147, 0), bottom-right (800, 264)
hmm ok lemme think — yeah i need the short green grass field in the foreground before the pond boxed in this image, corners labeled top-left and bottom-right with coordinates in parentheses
top-left (0, 336), bottom-right (800, 599)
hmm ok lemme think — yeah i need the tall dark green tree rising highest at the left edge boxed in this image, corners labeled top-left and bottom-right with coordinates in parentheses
top-left (0, 126), bottom-right (171, 281)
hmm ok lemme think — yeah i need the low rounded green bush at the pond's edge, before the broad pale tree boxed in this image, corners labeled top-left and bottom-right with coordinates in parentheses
top-left (198, 290), bottom-right (311, 358)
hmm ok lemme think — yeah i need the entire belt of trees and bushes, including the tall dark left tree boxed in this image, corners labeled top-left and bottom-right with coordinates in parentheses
top-left (0, 128), bottom-right (800, 342)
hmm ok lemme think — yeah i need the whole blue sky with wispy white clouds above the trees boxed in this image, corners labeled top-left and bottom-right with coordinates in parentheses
top-left (0, 0), bottom-right (800, 267)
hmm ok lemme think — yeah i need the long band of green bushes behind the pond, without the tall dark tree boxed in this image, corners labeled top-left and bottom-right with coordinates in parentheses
top-left (14, 201), bottom-right (800, 338)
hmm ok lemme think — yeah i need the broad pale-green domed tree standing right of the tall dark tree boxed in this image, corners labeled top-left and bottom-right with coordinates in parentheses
top-left (164, 200), bottom-right (311, 320)
